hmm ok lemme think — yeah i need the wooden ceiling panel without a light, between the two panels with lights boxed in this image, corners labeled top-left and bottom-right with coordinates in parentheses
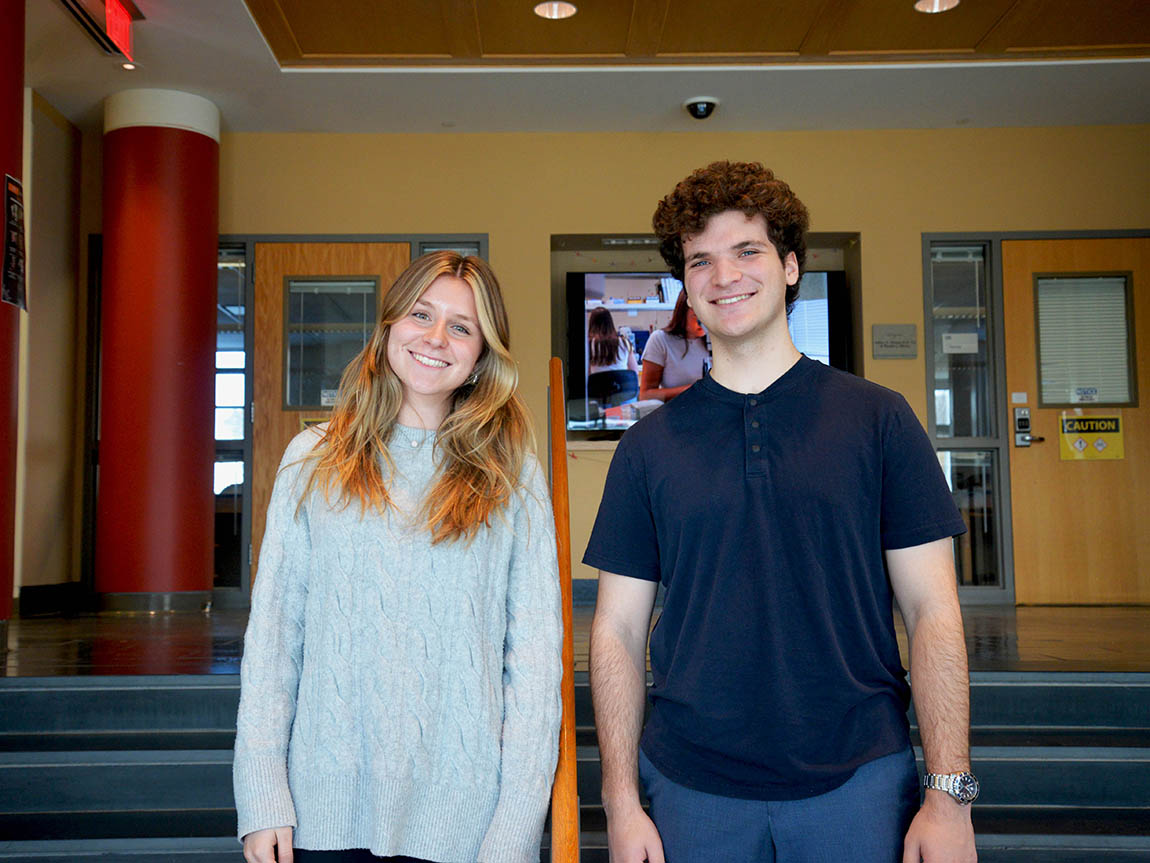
top-left (659, 0), bottom-right (825, 58)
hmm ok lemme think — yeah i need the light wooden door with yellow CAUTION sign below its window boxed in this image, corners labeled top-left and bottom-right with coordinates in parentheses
top-left (1003, 238), bottom-right (1150, 604)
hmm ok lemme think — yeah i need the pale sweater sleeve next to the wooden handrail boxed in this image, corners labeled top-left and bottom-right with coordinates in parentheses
top-left (480, 458), bottom-right (564, 863)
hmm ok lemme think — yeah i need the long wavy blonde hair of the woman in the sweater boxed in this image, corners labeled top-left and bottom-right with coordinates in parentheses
top-left (301, 251), bottom-right (535, 544)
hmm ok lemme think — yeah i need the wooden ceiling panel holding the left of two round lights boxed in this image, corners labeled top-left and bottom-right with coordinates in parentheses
top-left (475, 0), bottom-right (631, 60)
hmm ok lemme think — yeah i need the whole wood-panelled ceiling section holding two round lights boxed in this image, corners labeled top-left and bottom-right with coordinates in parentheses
top-left (245, 0), bottom-right (1150, 68)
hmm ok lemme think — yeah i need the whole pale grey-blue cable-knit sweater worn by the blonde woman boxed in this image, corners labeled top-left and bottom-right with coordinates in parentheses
top-left (233, 427), bottom-right (562, 863)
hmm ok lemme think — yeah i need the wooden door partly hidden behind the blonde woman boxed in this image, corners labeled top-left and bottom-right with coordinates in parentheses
top-left (252, 243), bottom-right (411, 585)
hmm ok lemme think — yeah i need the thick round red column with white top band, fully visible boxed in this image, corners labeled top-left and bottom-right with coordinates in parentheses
top-left (95, 90), bottom-right (220, 608)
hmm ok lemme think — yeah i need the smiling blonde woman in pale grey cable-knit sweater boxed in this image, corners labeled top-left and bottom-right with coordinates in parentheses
top-left (235, 252), bottom-right (562, 863)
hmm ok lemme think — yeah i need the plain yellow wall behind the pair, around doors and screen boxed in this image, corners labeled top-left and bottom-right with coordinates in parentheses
top-left (220, 125), bottom-right (1150, 575)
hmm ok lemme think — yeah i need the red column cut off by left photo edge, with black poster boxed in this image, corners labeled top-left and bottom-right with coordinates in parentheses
top-left (0, 0), bottom-right (24, 630)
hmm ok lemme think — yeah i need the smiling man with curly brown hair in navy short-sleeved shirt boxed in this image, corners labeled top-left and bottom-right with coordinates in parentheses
top-left (583, 162), bottom-right (976, 863)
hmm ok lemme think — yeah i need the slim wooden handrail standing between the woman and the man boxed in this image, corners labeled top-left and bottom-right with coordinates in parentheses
top-left (550, 357), bottom-right (578, 863)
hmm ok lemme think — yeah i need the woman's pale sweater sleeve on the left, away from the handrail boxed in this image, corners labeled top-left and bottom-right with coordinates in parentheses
top-left (232, 430), bottom-right (317, 839)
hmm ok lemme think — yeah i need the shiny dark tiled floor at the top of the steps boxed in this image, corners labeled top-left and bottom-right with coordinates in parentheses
top-left (0, 606), bottom-right (1150, 677)
